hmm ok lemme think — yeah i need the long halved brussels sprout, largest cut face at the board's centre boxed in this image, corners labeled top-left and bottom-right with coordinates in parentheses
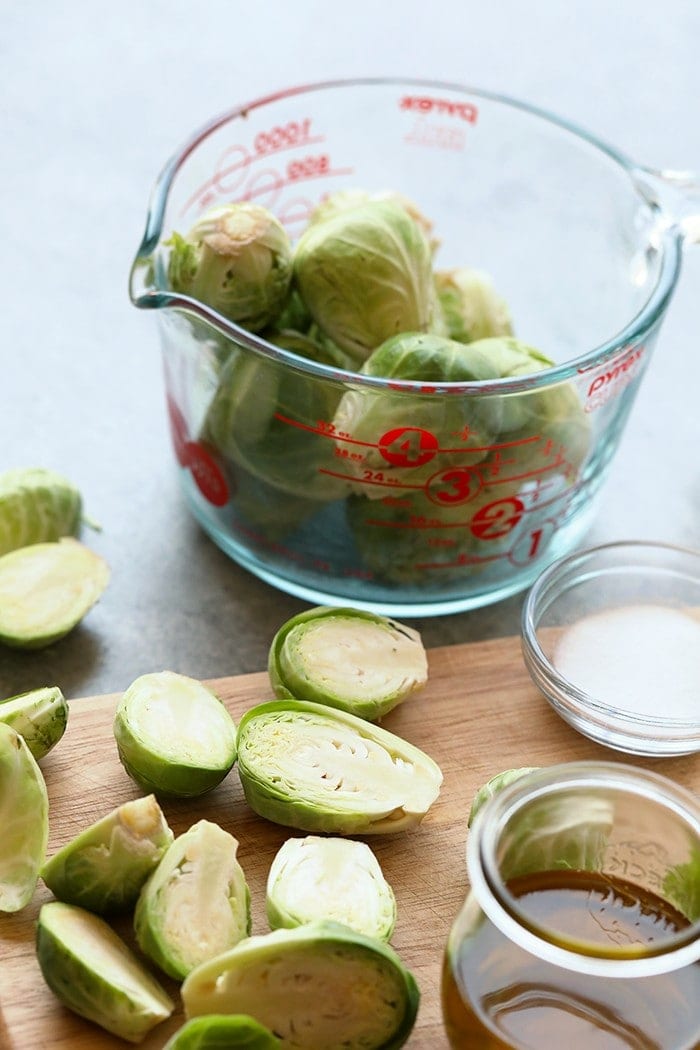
top-left (238, 700), bottom-right (442, 835)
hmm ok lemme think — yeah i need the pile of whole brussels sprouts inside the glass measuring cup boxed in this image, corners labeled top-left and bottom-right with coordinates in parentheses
top-left (167, 190), bottom-right (589, 582)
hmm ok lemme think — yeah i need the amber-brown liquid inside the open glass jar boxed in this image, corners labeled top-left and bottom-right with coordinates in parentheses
top-left (442, 872), bottom-right (700, 1050)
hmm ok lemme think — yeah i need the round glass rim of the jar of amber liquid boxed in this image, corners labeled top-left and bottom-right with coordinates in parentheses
top-left (466, 761), bottom-right (700, 979)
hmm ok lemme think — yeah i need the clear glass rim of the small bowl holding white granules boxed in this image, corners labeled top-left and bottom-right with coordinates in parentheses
top-left (521, 540), bottom-right (700, 739)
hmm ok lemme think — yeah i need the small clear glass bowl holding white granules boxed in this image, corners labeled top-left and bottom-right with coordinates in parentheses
top-left (522, 541), bottom-right (700, 756)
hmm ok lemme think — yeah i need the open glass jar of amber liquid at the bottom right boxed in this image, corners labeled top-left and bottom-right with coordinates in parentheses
top-left (442, 762), bottom-right (700, 1050)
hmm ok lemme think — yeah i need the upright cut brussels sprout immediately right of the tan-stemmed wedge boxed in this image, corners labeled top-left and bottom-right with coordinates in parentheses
top-left (134, 820), bottom-right (251, 980)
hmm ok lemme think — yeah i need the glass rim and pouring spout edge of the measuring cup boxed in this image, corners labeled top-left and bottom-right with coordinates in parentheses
top-left (129, 77), bottom-right (682, 397)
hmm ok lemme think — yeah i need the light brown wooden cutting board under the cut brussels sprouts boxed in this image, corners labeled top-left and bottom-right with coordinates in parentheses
top-left (0, 638), bottom-right (700, 1050)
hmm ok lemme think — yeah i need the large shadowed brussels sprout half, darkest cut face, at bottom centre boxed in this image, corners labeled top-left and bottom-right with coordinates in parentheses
top-left (182, 922), bottom-right (420, 1050)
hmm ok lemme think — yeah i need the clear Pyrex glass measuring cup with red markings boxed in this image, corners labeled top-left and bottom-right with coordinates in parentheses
top-left (130, 80), bottom-right (700, 615)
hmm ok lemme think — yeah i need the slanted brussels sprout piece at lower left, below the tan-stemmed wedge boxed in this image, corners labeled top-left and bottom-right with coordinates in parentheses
top-left (37, 901), bottom-right (174, 1043)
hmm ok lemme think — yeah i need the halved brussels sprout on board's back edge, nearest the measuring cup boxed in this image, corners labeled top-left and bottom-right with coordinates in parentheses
top-left (268, 606), bottom-right (428, 719)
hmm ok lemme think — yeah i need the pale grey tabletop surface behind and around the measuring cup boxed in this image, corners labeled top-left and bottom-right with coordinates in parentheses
top-left (0, 0), bottom-right (700, 697)
